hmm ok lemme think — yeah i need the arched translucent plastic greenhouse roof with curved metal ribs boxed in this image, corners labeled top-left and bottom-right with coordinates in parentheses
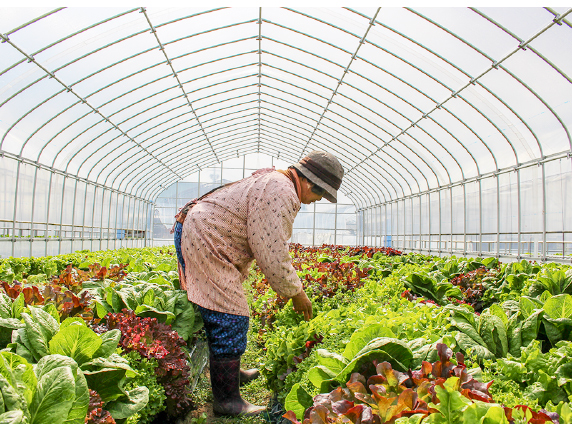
top-left (0, 7), bottom-right (572, 211)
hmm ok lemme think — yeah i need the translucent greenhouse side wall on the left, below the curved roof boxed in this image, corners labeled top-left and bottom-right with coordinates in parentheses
top-left (0, 153), bottom-right (152, 257)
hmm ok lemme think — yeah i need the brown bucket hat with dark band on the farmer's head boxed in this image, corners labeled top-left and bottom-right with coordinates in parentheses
top-left (292, 150), bottom-right (344, 203)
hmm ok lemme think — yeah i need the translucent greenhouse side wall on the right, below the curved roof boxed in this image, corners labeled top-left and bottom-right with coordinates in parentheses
top-left (358, 156), bottom-right (572, 262)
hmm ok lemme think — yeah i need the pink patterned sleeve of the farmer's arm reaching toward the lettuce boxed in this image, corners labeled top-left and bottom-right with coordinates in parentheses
top-left (247, 177), bottom-right (302, 298)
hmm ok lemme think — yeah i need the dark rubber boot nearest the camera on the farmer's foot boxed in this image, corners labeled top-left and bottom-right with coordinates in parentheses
top-left (210, 357), bottom-right (266, 416)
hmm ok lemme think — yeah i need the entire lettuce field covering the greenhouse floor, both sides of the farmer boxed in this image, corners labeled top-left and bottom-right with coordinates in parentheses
top-left (0, 245), bottom-right (572, 424)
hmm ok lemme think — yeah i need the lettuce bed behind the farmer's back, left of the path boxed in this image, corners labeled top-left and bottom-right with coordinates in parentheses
top-left (0, 248), bottom-right (206, 424)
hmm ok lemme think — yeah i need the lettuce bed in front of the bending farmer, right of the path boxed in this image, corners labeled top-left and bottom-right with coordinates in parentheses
top-left (248, 246), bottom-right (572, 423)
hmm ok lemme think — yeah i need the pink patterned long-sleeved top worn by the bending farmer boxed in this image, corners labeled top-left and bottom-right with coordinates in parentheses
top-left (181, 168), bottom-right (302, 316)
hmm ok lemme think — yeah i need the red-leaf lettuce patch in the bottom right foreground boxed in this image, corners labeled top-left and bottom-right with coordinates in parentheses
top-left (284, 344), bottom-right (559, 424)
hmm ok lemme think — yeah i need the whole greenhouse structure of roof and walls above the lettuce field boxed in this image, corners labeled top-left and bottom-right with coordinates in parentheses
top-left (0, 7), bottom-right (572, 262)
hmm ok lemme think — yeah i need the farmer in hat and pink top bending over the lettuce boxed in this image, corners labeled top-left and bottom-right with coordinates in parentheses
top-left (174, 151), bottom-right (344, 415)
